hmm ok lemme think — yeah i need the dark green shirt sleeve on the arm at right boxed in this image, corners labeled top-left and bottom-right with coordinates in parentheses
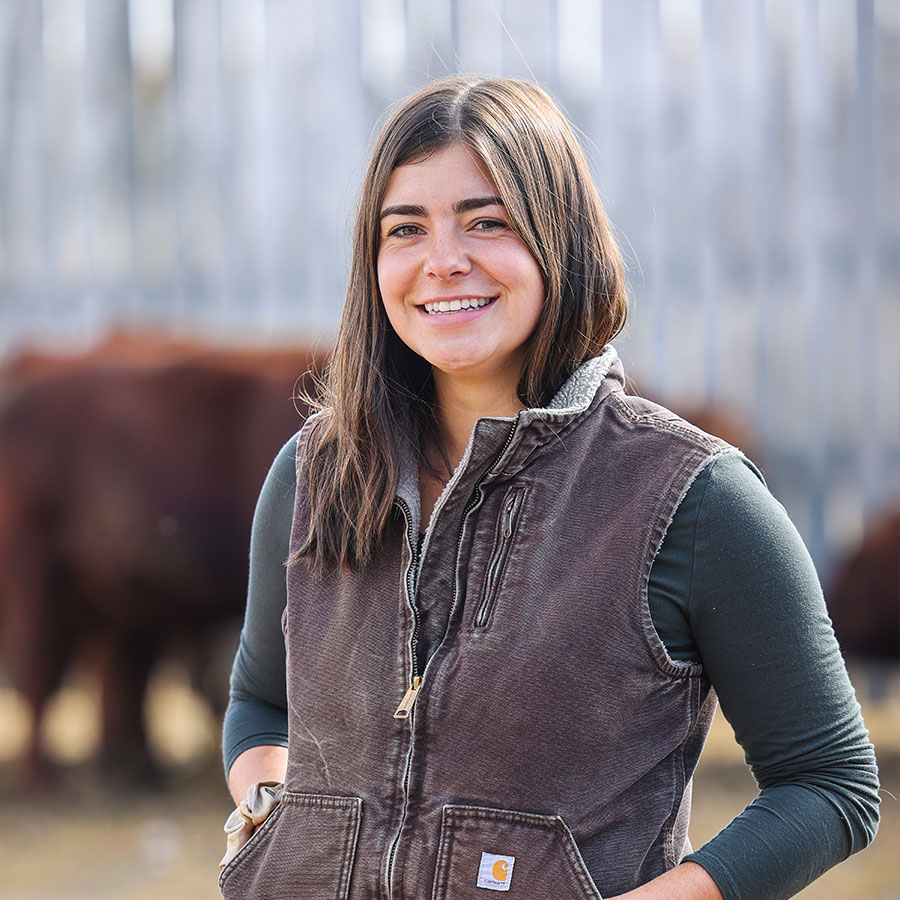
top-left (683, 455), bottom-right (879, 900)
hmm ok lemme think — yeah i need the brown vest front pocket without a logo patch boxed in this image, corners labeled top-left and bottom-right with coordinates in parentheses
top-left (219, 791), bottom-right (362, 900)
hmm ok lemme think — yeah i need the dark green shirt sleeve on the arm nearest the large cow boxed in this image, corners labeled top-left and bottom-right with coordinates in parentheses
top-left (222, 434), bottom-right (297, 777)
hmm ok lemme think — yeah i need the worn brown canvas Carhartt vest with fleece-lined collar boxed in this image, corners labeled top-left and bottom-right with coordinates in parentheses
top-left (222, 349), bottom-right (728, 900)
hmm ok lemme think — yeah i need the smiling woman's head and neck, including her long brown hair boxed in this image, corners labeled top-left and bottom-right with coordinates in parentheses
top-left (288, 79), bottom-right (627, 565)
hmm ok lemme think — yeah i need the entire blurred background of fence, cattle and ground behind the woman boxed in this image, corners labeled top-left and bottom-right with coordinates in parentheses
top-left (0, 0), bottom-right (900, 900)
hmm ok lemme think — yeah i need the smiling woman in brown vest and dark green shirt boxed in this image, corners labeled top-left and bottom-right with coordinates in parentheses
top-left (220, 78), bottom-right (878, 900)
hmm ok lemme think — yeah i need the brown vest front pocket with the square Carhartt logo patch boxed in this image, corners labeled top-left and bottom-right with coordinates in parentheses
top-left (432, 806), bottom-right (602, 900)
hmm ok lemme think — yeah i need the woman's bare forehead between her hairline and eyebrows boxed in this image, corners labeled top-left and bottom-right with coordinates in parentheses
top-left (381, 143), bottom-right (498, 209)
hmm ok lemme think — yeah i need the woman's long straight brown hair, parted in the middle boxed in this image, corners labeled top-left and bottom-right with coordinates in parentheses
top-left (291, 77), bottom-right (627, 567)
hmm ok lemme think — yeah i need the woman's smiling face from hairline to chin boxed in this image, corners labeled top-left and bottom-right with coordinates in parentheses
top-left (377, 143), bottom-right (544, 387)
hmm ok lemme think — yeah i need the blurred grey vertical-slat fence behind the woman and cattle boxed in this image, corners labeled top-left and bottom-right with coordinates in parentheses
top-left (0, 0), bottom-right (900, 570)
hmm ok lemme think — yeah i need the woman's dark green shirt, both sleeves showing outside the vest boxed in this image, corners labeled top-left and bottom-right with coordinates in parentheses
top-left (223, 436), bottom-right (879, 900)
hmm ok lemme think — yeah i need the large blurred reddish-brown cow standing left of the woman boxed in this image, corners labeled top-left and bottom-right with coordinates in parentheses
top-left (0, 339), bottom-right (324, 782)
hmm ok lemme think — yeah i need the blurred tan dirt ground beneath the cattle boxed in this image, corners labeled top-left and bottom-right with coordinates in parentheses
top-left (0, 668), bottom-right (900, 900)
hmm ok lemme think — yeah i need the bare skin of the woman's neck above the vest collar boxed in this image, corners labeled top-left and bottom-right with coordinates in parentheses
top-left (434, 370), bottom-right (523, 471)
